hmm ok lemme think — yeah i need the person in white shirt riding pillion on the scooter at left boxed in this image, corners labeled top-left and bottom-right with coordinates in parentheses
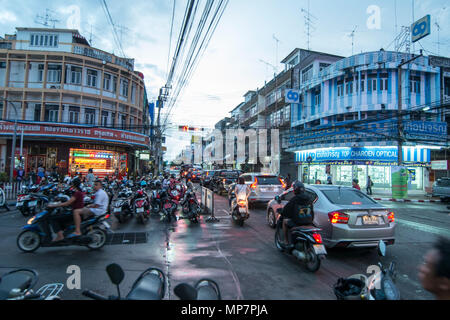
top-left (68, 180), bottom-right (109, 238)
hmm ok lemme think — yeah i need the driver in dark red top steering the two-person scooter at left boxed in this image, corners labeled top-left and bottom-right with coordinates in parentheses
top-left (48, 179), bottom-right (84, 242)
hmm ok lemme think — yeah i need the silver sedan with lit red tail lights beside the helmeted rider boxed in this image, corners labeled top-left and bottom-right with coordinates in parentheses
top-left (267, 185), bottom-right (395, 248)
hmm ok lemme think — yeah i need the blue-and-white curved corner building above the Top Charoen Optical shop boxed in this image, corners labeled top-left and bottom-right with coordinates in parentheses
top-left (287, 50), bottom-right (448, 190)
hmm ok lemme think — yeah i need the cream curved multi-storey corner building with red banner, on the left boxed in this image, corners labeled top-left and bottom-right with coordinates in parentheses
top-left (0, 28), bottom-right (149, 176)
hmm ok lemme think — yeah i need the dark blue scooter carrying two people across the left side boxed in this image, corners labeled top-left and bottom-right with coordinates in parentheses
top-left (17, 197), bottom-right (110, 252)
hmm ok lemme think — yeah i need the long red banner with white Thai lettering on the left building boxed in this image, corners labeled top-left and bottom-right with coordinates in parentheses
top-left (0, 121), bottom-right (149, 147)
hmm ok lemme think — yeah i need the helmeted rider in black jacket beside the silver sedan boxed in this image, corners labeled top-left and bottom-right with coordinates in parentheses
top-left (281, 181), bottom-right (314, 249)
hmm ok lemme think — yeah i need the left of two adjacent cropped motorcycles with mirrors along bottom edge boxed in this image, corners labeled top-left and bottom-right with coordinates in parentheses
top-left (83, 264), bottom-right (166, 300)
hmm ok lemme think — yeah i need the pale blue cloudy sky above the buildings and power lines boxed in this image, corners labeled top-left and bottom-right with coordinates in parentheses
top-left (0, 0), bottom-right (450, 159)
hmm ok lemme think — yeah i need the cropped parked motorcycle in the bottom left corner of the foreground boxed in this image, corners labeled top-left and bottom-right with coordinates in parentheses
top-left (0, 269), bottom-right (64, 300)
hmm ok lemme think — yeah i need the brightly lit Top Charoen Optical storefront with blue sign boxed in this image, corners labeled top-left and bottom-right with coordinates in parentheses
top-left (296, 146), bottom-right (431, 190)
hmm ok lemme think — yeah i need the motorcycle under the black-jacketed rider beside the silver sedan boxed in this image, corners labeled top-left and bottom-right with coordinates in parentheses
top-left (275, 208), bottom-right (327, 272)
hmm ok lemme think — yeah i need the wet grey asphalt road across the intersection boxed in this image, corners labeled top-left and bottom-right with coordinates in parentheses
top-left (0, 191), bottom-right (450, 300)
